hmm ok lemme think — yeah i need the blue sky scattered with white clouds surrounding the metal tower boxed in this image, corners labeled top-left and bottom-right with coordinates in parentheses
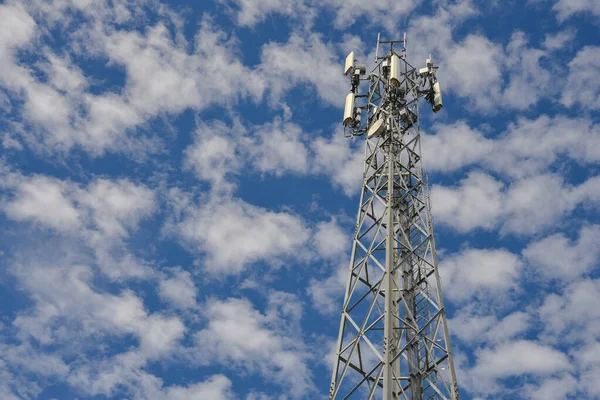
top-left (0, 0), bottom-right (600, 400)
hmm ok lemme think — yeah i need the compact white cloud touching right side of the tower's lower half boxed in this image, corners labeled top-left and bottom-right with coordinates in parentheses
top-left (440, 249), bottom-right (521, 301)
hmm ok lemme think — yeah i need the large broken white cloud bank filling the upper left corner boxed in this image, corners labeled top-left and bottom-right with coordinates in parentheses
top-left (0, 6), bottom-right (266, 156)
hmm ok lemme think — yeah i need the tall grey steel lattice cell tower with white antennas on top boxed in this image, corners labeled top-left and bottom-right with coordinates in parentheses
top-left (329, 35), bottom-right (459, 400)
